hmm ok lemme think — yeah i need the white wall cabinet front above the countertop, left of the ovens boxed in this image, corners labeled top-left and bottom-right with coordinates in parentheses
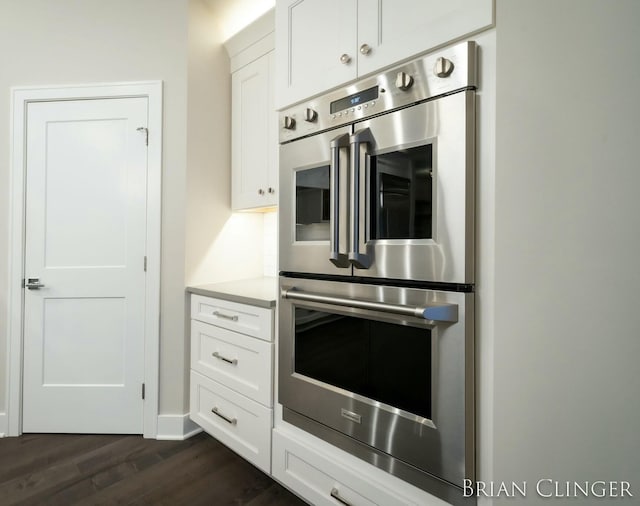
top-left (231, 53), bottom-right (277, 209)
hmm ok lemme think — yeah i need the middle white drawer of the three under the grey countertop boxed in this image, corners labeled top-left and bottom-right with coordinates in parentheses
top-left (191, 320), bottom-right (273, 408)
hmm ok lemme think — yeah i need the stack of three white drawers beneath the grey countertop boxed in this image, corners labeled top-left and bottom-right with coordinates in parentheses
top-left (189, 294), bottom-right (274, 473)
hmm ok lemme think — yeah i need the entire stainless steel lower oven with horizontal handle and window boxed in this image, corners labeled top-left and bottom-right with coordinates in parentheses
top-left (278, 277), bottom-right (475, 504)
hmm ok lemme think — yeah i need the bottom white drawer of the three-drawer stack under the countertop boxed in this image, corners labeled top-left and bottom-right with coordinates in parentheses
top-left (190, 371), bottom-right (273, 474)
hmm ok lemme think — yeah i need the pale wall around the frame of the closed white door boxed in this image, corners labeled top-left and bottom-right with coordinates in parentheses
top-left (0, 0), bottom-right (187, 422)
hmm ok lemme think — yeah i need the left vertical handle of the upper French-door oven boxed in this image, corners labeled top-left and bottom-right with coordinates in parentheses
top-left (329, 134), bottom-right (350, 268)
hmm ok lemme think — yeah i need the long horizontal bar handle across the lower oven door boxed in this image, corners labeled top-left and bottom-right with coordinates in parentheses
top-left (281, 288), bottom-right (458, 323)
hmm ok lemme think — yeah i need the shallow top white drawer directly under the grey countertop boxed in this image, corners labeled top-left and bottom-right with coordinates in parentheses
top-left (191, 294), bottom-right (273, 341)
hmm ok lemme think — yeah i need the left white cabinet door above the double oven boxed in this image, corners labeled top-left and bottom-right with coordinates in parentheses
top-left (276, 0), bottom-right (358, 108)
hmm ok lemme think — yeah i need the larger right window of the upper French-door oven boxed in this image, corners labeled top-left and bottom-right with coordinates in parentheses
top-left (369, 144), bottom-right (433, 240)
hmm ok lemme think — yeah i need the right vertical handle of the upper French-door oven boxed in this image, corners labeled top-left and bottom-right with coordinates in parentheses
top-left (349, 128), bottom-right (374, 269)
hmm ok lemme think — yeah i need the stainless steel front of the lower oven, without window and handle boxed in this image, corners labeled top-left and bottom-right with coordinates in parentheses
top-left (278, 277), bottom-right (475, 487)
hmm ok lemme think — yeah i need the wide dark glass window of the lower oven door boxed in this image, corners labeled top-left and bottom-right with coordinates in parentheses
top-left (294, 307), bottom-right (431, 419)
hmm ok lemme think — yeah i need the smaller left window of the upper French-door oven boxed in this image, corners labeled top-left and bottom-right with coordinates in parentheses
top-left (295, 165), bottom-right (330, 241)
